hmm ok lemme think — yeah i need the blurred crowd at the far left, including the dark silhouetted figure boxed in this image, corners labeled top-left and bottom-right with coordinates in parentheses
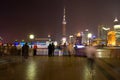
top-left (0, 43), bottom-right (36, 56)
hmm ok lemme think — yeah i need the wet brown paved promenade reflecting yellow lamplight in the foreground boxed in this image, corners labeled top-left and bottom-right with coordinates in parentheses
top-left (0, 56), bottom-right (120, 80)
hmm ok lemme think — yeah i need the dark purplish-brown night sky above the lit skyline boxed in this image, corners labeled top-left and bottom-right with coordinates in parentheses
top-left (0, 0), bottom-right (120, 42)
